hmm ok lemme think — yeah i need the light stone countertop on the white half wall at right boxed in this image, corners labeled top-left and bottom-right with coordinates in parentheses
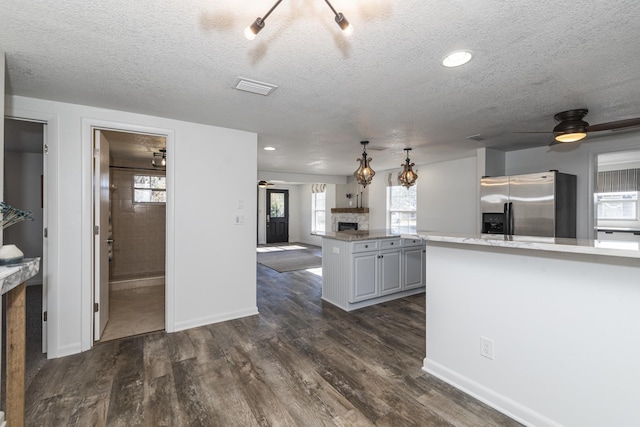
top-left (402, 231), bottom-right (640, 259)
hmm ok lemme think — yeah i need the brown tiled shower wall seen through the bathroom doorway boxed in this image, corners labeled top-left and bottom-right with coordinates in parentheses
top-left (109, 168), bottom-right (166, 282)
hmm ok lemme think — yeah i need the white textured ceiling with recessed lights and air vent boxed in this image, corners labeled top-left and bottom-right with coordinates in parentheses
top-left (0, 0), bottom-right (640, 175)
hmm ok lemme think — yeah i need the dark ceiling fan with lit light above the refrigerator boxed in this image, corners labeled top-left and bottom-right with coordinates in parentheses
top-left (515, 108), bottom-right (640, 145)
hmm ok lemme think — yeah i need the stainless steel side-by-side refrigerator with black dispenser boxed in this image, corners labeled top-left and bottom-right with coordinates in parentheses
top-left (480, 171), bottom-right (576, 237)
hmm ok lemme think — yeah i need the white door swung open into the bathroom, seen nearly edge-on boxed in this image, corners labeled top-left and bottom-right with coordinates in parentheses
top-left (93, 129), bottom-right (110, 341)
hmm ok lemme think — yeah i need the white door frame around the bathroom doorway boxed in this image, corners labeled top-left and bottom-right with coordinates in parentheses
top-left (81, 117), bottom-right (175, 351)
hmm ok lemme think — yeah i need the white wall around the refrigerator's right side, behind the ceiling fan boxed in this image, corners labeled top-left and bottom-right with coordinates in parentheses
top-left (506, 132), bottom-right (640, 238)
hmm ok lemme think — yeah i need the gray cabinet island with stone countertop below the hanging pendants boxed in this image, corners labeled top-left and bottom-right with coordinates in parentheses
top-left (318, 230), bottom-right (425, 311)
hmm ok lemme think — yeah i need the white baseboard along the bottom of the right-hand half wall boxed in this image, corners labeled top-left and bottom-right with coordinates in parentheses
top-left (422, 358), bottom-right (562, 427)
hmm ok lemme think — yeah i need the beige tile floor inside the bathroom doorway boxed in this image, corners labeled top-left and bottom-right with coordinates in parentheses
top-left (100, 285), bottom-right (165, 342)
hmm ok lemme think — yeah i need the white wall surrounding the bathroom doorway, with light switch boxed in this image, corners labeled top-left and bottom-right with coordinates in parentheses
top-left (5, 96), bottom-right (257, 357)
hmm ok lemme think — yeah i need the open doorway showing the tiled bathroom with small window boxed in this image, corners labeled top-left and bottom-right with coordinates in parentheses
top-left (93, 129), bottom-right (167, 342)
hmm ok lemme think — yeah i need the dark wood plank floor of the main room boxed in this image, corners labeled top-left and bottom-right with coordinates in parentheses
top-left (27, 249), bottom-right (520, 427)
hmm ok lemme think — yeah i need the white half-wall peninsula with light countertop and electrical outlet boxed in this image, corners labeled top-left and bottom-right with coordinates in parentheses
top-left (415, 232), bottom-right (640, 427)
